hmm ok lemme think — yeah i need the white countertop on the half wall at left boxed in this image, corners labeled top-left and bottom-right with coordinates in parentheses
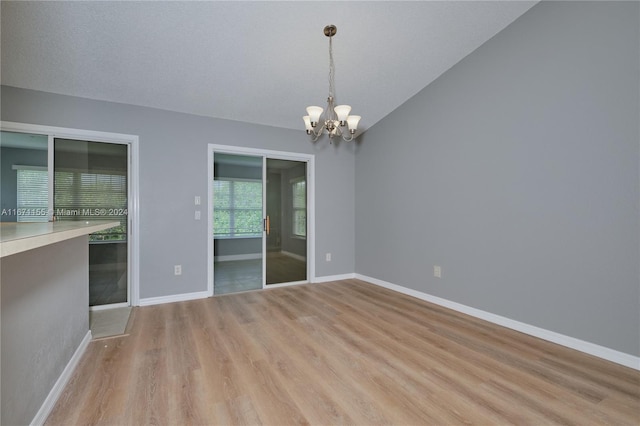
top-left (0, 220), bottom-right (120, 257)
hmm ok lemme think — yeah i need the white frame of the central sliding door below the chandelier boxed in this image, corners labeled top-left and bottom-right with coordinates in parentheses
top-left (207, 144), bottom-right (316, 296)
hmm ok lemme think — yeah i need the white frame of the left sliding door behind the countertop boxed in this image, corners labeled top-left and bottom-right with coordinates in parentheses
top-left (0, 121), bottom-right (140, 306)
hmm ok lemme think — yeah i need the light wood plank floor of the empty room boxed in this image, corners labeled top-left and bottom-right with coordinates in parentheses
top-left (47, 280), bottom-right (640, 425)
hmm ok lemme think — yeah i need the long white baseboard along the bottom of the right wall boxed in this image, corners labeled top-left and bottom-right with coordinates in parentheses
top-left (355, 274), bottom-right (640, 370)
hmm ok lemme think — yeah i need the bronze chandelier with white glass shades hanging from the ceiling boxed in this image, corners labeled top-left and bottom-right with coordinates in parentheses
top-left (302, 25), bottom-right (360, 142)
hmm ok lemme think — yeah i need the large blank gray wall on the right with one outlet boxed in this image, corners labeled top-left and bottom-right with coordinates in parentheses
top-left (356, 2), bottom-right (640, 356)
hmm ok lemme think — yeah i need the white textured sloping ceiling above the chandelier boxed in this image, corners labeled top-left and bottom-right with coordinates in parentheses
top-left (1, 0), bottom-right (536, 133)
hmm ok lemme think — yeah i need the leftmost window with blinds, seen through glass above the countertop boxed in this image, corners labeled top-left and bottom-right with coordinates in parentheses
top-left (13, 166), bottom-right (49, 222)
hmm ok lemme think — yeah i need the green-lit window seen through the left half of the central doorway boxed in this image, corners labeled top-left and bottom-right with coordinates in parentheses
top-left (213, 178), bottom-right (262, 238)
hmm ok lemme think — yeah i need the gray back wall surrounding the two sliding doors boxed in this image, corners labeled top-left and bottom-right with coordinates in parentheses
top-left (1, 86), bottom-right (355, 298)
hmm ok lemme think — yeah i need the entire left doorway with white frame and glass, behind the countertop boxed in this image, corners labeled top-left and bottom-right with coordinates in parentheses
top-left (0, 122), bottom-right (139, 316)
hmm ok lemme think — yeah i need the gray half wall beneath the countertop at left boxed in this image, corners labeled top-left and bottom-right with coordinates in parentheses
top-left (0, 236), bottom-right (89, 425)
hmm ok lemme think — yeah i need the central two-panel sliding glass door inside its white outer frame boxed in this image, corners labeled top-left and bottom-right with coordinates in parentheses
top-left (209, 151), bottom-right (309, 294)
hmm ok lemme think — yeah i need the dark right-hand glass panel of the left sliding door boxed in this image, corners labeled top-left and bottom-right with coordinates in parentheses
top-left (53, 138), bottom-right (129, 307)
